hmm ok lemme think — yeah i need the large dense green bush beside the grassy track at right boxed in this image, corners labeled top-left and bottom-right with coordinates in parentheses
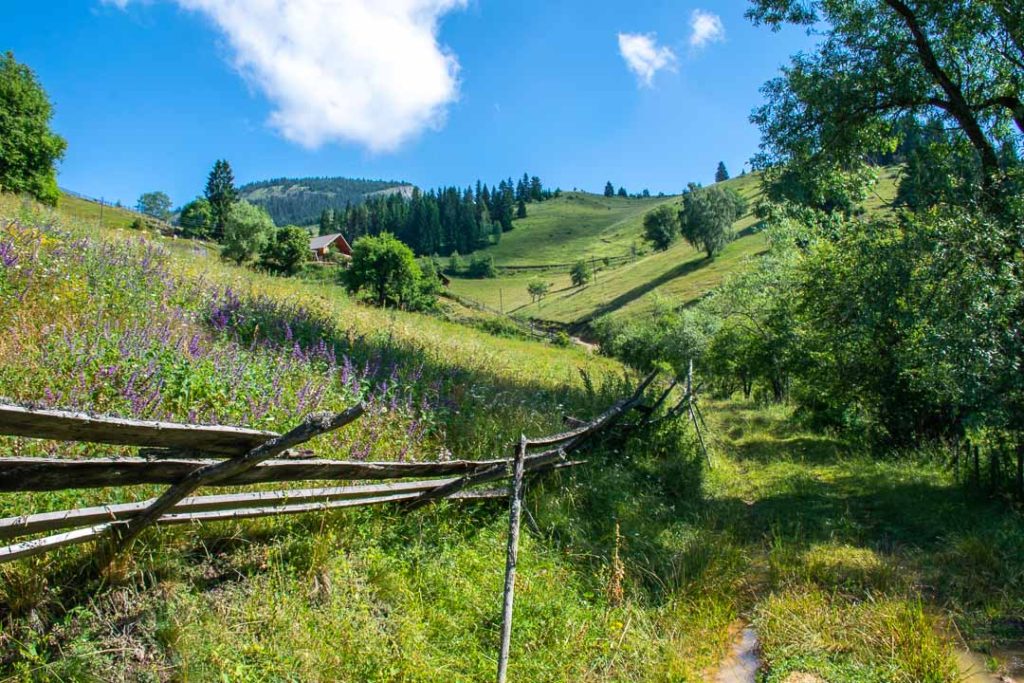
top-left (799, 211), bottom-right (1024, 443)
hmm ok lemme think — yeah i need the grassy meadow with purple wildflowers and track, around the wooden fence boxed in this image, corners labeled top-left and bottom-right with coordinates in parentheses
top-left (0, 188), bottom-right (1024, 683)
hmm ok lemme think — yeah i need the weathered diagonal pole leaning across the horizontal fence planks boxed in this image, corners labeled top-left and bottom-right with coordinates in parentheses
top-left (114, 401), bottom-right (367, 550)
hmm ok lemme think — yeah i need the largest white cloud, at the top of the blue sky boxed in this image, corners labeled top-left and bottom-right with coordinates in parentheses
top-left (103, 0), bottom-right (467, 152)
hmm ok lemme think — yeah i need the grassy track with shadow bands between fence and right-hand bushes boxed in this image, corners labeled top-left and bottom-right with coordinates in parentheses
top-left (708, 403), bottom-right (1024, 683)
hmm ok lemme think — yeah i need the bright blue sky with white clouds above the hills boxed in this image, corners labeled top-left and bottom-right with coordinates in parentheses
top-left (0, 0), bottom-right (809, 204)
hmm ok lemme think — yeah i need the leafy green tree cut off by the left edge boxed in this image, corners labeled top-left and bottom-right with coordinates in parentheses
top-left (0, 52), bottom-right (68, 206)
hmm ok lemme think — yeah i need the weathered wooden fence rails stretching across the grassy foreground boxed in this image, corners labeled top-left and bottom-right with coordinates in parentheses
top-left (0, 374), bottom-right (671, 563)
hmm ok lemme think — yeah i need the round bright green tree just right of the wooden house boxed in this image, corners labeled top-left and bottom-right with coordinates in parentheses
top-left (345, 232), bottom-right (422, 307)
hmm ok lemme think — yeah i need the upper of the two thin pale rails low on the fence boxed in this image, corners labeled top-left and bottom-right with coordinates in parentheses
top-left (0, 479), bottom-right (453, 539)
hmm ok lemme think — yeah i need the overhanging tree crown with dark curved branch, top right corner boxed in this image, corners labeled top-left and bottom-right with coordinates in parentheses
top-left (748, 0), bottom-right (1024, 211)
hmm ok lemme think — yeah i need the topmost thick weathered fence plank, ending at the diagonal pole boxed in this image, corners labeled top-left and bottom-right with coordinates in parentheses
top-left (0, 404), bottom-right (278, 456)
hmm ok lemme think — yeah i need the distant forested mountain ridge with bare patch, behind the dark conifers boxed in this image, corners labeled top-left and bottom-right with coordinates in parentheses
top-left (239, 177), bottom-right (413, 225)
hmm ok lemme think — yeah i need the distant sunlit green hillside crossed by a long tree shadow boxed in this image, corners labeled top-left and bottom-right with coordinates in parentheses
top-left (452, 169), bottom-right (896, 324)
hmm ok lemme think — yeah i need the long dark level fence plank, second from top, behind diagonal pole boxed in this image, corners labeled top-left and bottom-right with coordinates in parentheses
top-left (0, 458), bottom-right (516, 493)
